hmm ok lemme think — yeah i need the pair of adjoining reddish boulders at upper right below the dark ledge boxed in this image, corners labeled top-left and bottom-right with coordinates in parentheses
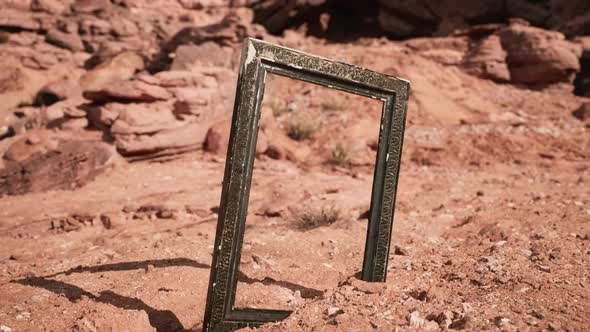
top-left (405, 20), bottom-right (582, 86)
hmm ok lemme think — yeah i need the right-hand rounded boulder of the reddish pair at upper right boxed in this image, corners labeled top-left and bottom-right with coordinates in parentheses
top-left (497, 22), bottom-right (582, 84)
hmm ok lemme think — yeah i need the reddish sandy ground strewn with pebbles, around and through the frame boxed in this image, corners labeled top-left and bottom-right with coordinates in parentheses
top-left (0, 40), bottom-right (590, 331)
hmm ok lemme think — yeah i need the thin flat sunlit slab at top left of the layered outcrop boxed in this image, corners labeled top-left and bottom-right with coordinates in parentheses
top-left (83, 80), bottom-right (172, 103)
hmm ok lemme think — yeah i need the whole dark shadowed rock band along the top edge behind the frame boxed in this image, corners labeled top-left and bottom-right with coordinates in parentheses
top-left (242, 0), bottom-right (590, 39)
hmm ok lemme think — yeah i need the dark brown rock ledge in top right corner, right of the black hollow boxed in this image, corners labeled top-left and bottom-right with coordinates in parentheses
top-left (378, 0), bottom-right (590, 38)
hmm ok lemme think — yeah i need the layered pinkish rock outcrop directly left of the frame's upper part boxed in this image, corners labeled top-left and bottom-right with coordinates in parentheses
top-left (84, 67), bottom-right (235, 160)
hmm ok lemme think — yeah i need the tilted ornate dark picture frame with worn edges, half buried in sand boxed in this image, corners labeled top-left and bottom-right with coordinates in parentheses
top-left (203, 38), bottom-right (410, 331)
